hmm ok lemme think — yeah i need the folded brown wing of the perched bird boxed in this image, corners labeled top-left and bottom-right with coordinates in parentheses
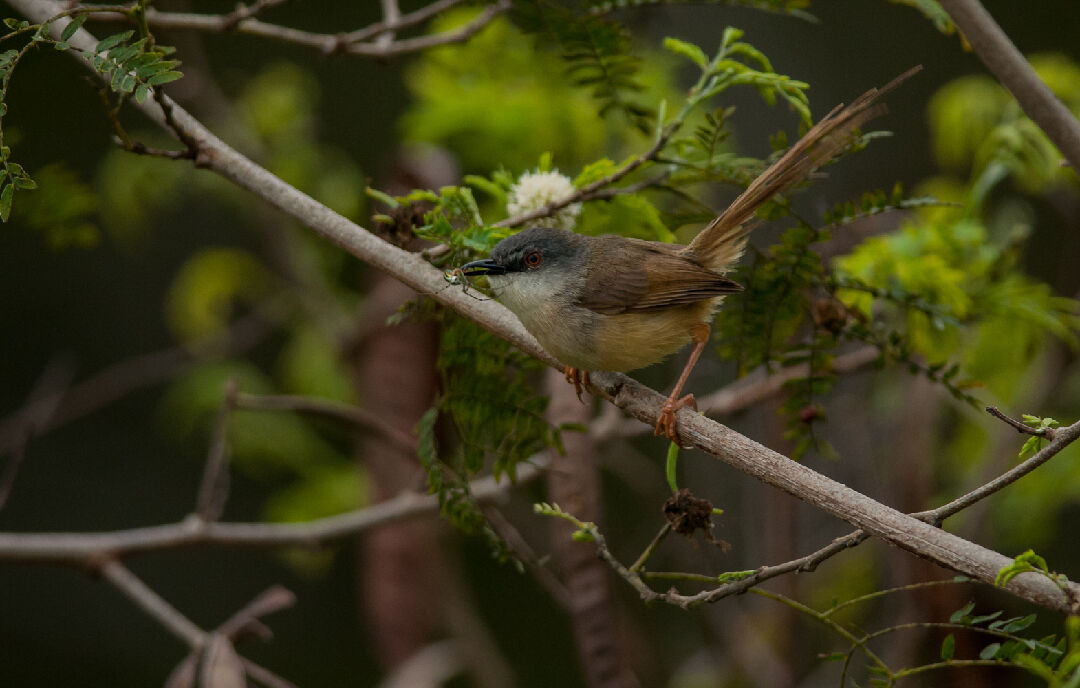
top-left (577, 235), bottom-right (742, 315)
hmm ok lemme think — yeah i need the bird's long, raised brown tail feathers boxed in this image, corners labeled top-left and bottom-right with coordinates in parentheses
top-left (686, 65), bottom-right (922, 270)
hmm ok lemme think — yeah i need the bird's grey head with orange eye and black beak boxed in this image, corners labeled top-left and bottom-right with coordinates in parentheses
top-left (461, 227), bottom-right (589, 316)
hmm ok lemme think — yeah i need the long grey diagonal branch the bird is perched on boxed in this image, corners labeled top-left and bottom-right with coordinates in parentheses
top-left (10, 0), bottom-right (1080, 610)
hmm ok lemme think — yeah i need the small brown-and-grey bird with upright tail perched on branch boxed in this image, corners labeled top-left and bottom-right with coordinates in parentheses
top-left (461, 67), bottom-right (921, 442)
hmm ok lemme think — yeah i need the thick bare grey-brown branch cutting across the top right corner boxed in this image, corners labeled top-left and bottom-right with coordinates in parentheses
top-left (941, 0), bottom-right (1080, 170)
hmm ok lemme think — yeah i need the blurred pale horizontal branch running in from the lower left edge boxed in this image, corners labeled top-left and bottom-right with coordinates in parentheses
top-left (0, 456), bottom-right (546, 566)
